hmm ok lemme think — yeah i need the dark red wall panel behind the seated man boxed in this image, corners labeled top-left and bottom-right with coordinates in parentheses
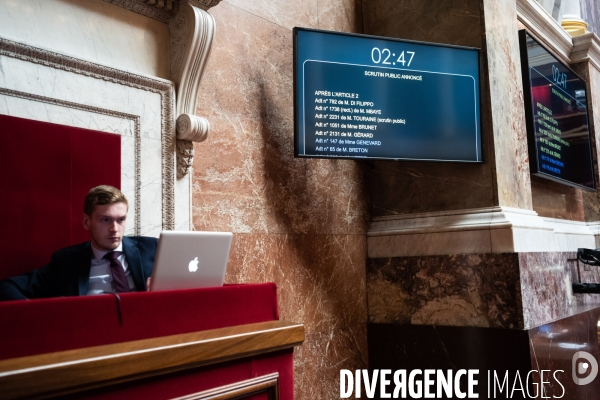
top-left (0, 115), bottom-right (121, 279)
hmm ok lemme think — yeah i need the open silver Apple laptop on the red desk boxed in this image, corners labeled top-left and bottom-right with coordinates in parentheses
top-left (150, 231), bottom-right (233, 291)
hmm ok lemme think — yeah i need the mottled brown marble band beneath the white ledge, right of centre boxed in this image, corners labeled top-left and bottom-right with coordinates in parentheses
top-left (367, 252), bottom-right (600, 329)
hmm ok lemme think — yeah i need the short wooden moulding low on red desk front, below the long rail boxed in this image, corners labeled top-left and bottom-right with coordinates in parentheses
top-left (171, 372), bottom-right (279, 400)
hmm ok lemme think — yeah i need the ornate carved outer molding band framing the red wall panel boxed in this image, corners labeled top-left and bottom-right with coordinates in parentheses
top-left (0, 37), bottom-right (175, 230)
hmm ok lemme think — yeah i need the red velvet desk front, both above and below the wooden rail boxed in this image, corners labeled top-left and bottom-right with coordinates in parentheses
top-left (0, 283), bottom-right (300, 399)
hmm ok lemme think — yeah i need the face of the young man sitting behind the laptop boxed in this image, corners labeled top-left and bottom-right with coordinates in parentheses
top-left (83, 203), bottom-right (127, 251)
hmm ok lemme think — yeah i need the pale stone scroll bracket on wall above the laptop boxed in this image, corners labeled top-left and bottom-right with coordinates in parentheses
top-left (169, 0), bottom-right (221, 179)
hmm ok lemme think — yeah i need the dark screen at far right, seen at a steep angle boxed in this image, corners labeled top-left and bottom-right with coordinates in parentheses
top-left (519, 30), bottom-right (596, 190)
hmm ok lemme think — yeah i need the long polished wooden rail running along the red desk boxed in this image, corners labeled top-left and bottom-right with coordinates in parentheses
top-left (0, 321), bottom-right (304, 399)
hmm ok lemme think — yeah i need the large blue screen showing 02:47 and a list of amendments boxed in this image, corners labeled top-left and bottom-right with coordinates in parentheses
top-left (294, 28), bottom-right (482, 163)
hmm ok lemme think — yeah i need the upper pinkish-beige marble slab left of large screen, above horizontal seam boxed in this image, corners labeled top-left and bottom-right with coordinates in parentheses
top-left (194, 3), bottom-right (368, 234)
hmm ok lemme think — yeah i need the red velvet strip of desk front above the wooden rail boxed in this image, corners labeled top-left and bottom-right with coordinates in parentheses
top-left (0, 283), bottom-right (279, 358)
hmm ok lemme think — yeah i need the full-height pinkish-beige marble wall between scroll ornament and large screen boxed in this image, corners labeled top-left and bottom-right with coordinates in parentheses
top-left (192, 0), bottom-right (370, 399)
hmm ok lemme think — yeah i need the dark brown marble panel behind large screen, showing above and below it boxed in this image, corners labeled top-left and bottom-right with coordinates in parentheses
top-left (364, 0), bottom-right (497, 216)
